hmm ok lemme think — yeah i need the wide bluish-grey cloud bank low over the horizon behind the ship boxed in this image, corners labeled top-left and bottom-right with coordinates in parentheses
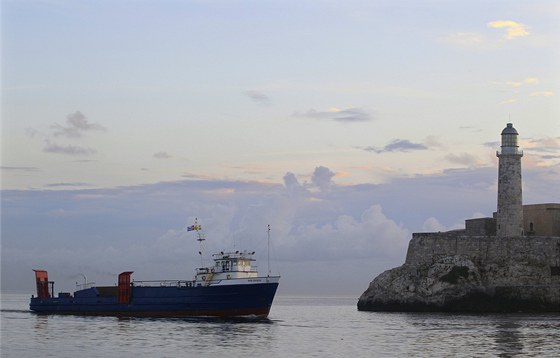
top-left (0, 164), bottom-right (560, 295)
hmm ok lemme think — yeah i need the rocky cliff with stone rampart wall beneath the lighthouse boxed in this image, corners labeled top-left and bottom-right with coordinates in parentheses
top-left (358, 232), bottom-right (560, 312)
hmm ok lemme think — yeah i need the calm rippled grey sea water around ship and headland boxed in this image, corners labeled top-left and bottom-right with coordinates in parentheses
top-left (1, 294), bottom-right (560, 358)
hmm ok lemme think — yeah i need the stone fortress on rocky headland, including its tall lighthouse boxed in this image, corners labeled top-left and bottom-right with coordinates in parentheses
top-left (358, 123), bottom-right (560, 312)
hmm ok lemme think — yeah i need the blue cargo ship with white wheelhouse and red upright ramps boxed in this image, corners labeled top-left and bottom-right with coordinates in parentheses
top-left (29, 225), bottom-right (280, 317)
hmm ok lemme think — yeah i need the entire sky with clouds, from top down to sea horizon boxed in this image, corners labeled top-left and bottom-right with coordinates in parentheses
top-left (0, 0), bottom-right (560, 298)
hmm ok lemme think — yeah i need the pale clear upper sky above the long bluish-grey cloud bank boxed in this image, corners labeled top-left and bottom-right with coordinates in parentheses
top-left (2, 1), bottom-right (560, 188)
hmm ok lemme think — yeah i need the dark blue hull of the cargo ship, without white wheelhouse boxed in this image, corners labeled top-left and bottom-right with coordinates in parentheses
top-left (29, 282), bottom-right (278, 317)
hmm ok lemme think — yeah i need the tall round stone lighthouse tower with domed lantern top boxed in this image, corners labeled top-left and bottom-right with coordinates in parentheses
top-left (496, 123), bottom-right (523, 237)
